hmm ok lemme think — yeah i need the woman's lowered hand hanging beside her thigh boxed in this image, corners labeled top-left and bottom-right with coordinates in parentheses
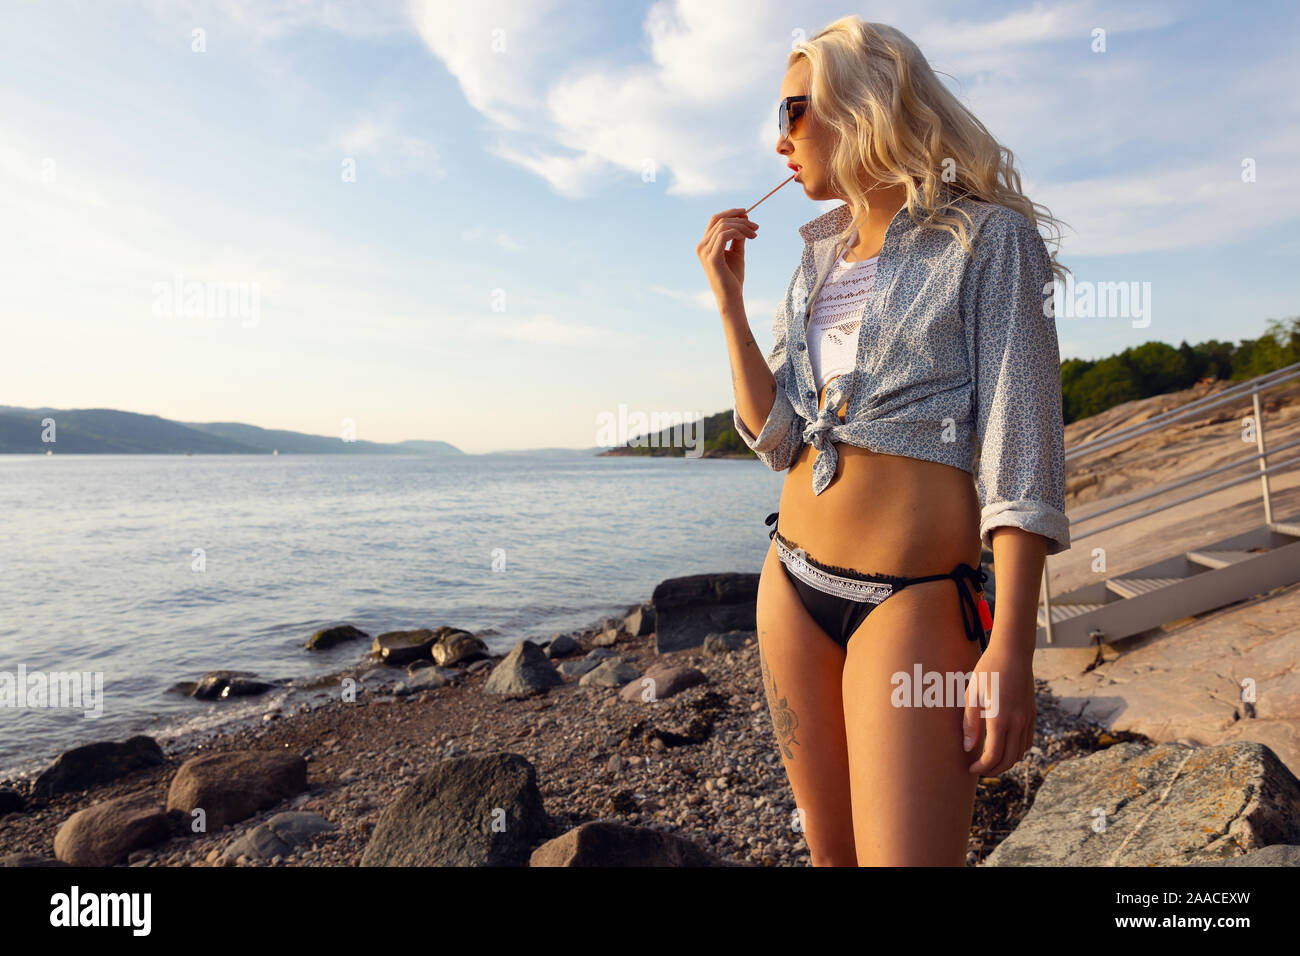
top-left (962, 636), bottom-right (1036, 777)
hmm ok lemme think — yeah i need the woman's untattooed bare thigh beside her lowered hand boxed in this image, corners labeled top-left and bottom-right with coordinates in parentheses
top-left (842, 580), bottom-right (980, 866)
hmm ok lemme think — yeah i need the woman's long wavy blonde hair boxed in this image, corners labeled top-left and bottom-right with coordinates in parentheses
top-left (787, 16), bottom-right (1069, 282)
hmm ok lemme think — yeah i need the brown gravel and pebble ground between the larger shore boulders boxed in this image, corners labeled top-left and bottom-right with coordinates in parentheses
top-left (0, 608), bottom-right (1128, 866)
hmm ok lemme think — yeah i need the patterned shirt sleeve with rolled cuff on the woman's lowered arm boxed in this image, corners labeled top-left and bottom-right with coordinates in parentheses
top-left (974, 216), bottom-right (1070, 554)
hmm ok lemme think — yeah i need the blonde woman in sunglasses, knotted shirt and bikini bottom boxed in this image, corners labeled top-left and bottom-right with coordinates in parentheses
top-left (697, 17), bottom-right (1070, 866)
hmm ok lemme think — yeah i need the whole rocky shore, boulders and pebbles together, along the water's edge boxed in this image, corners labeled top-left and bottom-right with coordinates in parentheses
top-left (0, 575), bottom-right (1300, 866)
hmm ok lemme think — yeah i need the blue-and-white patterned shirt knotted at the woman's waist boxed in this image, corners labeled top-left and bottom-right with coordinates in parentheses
top-left (732, 196), bottom-right (1070, 554)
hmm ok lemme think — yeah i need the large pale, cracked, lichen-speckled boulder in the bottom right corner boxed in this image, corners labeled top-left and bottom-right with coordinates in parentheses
top-left (984, 740), bottom-right (1300, 866)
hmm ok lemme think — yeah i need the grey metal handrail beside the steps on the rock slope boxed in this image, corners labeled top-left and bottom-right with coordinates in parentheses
top-left (1040, 362), bottom-right (1300, 645)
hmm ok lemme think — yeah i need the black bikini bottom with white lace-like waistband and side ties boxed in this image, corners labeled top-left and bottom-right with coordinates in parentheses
top-left (763, 511), bottom-right (993, 653)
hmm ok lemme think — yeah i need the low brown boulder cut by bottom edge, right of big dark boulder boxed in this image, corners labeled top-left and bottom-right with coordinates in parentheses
top-left (529, 821), bottom-right (732, 866)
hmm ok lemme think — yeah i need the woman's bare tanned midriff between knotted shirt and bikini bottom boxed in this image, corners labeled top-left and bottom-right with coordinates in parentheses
top-left (776, 378), bottom-right (980, 578)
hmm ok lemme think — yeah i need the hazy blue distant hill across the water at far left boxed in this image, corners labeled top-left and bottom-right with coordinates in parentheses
top-left (0, 406), bottom-right (464, 455)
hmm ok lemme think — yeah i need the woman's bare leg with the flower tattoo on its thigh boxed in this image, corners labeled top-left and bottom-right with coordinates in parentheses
top-left (757, 541), bottom-right (858, 866)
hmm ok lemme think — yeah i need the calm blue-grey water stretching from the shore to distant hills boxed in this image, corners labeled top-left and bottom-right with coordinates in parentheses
top-left (0, 453), bottom-right (783, 778)
